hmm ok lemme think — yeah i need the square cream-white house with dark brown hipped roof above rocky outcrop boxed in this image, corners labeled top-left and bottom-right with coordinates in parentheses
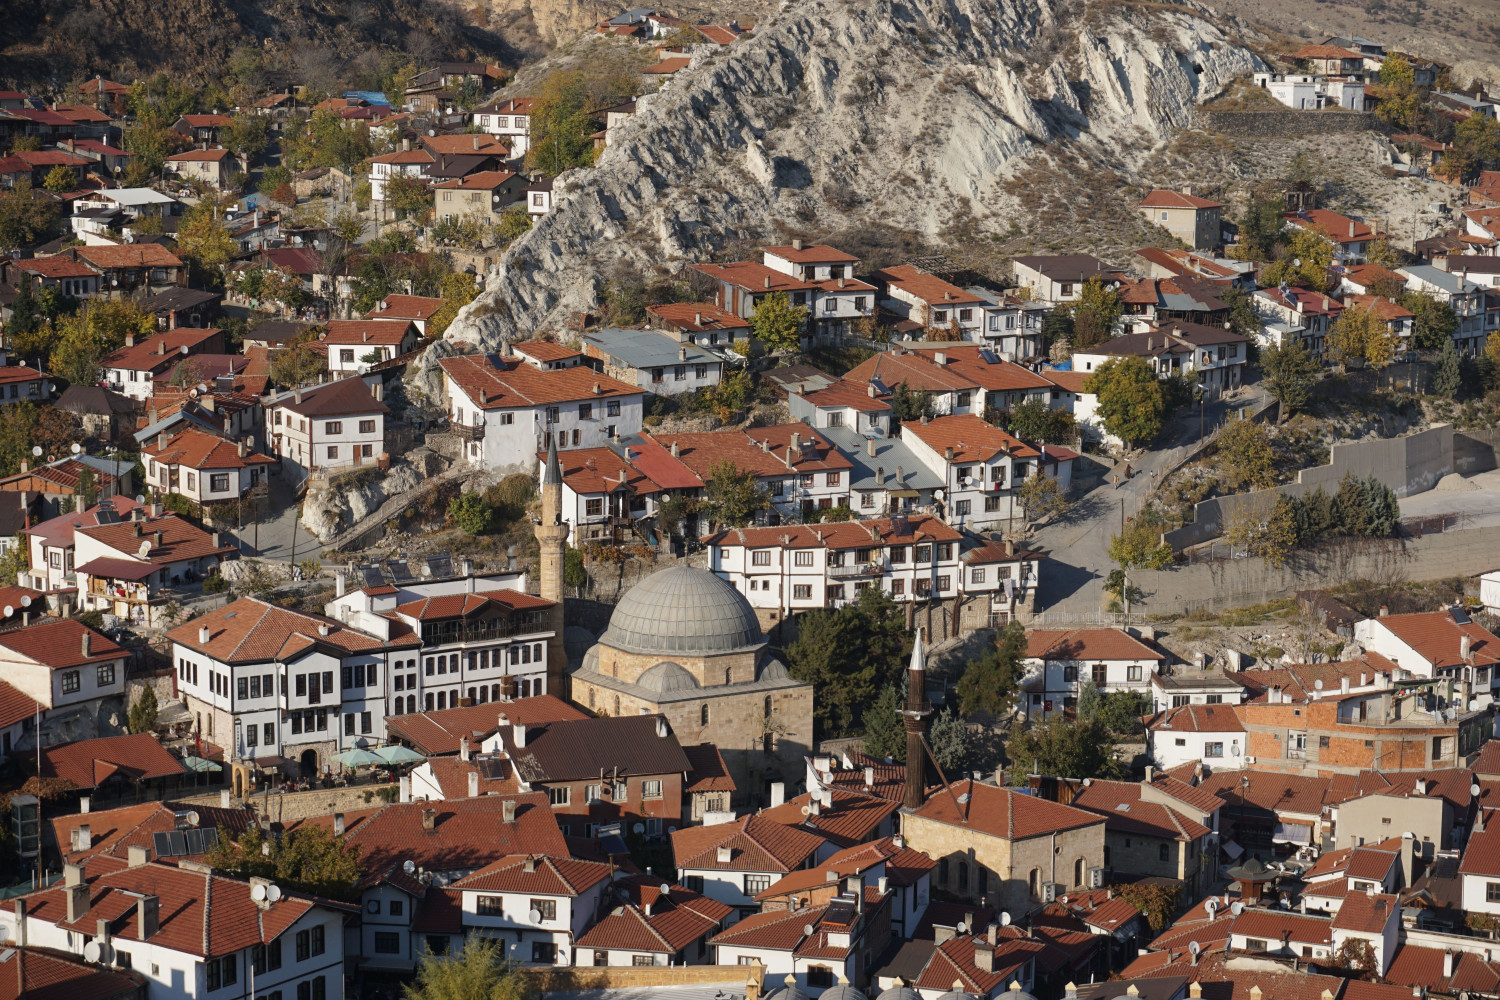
top-left (266, 378), bottom-right (390, 475)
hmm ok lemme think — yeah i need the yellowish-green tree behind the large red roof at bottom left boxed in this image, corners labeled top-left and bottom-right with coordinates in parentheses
top-left (209, 826), bottom-right (362, 900)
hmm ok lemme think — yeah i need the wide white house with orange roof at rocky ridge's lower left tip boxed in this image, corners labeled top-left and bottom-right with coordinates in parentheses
top-left (441, 354), bottom-right (645, 471)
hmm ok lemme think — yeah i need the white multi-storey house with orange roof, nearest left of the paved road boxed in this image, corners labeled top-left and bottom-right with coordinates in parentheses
top-left (902, 414), bottom-right (1077, 528)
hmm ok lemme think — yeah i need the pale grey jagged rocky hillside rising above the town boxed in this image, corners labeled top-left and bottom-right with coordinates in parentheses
top-left (420, 0), bottom-right (1260, 393)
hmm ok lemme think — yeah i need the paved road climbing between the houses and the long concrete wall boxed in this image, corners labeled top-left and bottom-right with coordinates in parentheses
top-left (1034, 387), bottom-right (1263, 613)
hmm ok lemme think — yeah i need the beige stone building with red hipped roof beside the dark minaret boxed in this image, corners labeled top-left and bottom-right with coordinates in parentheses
top-left (902, 780), bottom-right (1104, 915)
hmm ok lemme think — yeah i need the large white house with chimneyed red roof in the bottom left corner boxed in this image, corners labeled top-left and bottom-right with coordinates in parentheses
top-left (0, 847), bottom-right (354, 1000)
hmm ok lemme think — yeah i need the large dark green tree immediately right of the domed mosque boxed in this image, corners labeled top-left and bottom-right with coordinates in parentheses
top-left (788, 586), bottom-right (912, 739)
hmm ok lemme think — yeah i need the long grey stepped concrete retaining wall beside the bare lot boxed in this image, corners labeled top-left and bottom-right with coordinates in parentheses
top-left (1164, 424), bottom-right (1458, 550)
